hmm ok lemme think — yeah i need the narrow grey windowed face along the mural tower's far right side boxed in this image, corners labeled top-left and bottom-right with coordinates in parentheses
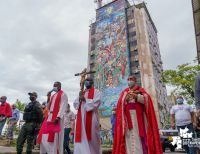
top-left (144, 6), bottom-right (168, 125)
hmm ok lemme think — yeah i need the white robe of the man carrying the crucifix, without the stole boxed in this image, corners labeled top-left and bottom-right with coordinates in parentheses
top-left (74, 89), bottom-right (102, 154)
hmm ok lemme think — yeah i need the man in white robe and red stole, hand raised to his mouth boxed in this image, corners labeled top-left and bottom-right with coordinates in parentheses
top-left (38, 82), bottom-right (68, 154)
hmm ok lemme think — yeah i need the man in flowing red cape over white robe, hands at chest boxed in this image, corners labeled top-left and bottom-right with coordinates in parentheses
top-left (112, 75), bottom-right (162, 154)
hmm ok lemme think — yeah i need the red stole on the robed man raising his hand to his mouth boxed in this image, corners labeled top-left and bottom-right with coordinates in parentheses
top-left (38, 90), bottom-right (63, 144)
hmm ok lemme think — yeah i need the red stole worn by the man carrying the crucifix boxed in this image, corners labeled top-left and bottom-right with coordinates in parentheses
top-left (75, 87), bottom-right (94, 142)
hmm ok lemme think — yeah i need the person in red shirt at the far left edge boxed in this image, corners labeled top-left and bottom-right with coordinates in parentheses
top-left (0, 96), bottom-right (12, 136)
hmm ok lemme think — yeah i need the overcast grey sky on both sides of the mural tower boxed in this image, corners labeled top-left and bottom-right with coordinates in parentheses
top-left (0, 0), bottom-right (196, 107)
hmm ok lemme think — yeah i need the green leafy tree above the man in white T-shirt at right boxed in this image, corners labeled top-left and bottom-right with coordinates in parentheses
top-left (162, 61), bottom-right (200, 104)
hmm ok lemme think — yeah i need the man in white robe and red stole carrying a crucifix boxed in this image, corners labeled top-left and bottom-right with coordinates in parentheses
top-left (74, 78), bottom-right (102, 154)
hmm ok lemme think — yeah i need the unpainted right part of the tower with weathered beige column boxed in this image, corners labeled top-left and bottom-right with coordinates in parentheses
top-left (127, 3), bottom-right (168, 127)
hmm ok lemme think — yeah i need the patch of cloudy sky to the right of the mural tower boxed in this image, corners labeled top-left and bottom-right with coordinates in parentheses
top-left (146, 0), bottom-right (196, 69)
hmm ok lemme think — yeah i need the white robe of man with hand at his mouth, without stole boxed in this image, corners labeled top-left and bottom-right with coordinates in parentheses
top-left (40, 92), bottom-right (68, 154)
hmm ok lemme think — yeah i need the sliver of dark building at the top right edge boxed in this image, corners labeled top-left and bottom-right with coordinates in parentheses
top-left (192, 0), bottom-right (200, 64)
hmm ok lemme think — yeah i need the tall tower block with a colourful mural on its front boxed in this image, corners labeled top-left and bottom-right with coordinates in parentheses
top-left (88, 0), bottom-right (168, 127)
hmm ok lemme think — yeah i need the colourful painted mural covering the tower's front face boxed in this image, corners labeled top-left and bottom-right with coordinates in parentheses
top-left (94, 0), bottom-right (130, 116)
